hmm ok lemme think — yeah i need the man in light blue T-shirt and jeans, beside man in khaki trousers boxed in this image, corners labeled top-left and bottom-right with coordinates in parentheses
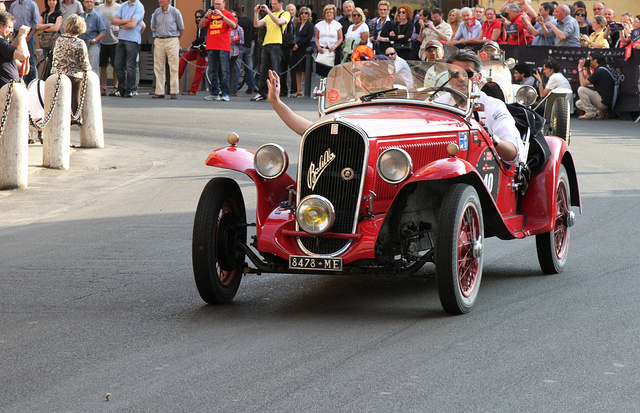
top-left (111, 0), bottom-right (144, 98)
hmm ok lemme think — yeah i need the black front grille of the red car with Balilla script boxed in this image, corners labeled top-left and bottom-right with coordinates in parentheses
top-left (298, 121), bottom-right (369, 255)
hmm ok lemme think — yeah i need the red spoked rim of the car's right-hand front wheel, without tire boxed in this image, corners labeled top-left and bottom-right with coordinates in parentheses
top-left (458, 203), bottom-right (482, 298)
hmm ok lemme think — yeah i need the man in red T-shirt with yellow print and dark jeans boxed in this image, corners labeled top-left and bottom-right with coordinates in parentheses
top-left (198, 0), bottom-right (238, 102)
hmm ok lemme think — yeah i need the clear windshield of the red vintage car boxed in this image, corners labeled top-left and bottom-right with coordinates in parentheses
top-left (324, 60), bottom-right (470, 112)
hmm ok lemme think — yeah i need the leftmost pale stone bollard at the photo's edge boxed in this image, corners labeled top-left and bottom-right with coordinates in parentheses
top-left (0, 83), bottom-right (29, 189)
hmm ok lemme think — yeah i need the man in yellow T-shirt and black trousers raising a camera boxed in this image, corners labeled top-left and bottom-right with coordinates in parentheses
top-left (251, 0), bottom-right (291, 102)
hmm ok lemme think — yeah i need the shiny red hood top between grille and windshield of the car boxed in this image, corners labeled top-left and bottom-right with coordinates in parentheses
top-left (322, 105), bottom-right (469, 138)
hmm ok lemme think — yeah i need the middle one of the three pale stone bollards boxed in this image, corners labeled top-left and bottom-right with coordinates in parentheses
top-left (42, 74), bottom-right (71, 169)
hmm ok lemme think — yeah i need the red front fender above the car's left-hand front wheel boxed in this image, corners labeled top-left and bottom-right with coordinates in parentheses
top-left (206, 146), bottom-right (295, 227)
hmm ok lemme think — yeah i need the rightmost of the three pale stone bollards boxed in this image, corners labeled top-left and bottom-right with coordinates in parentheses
top-left (80, 71), bottom-right (104, 148)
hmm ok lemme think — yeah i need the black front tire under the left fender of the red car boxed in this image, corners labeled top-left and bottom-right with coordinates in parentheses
top-left (191, 178), bottom-right (247, 304)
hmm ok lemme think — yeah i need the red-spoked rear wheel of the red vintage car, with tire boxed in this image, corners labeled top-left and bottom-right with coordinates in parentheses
top-left (536, 165), bottom-right (571, 274)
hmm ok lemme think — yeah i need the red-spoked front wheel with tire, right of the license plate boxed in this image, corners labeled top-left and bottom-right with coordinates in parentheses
top-left (435, 184), bottom-right (484, 315)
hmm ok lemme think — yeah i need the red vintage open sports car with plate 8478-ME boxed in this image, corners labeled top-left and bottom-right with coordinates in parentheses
top-left (192, 61), bottom-right (580, 314)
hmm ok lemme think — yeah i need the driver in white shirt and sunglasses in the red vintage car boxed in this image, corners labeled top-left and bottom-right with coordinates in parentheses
top-left (437, 50), bottom-right (526, 165)
